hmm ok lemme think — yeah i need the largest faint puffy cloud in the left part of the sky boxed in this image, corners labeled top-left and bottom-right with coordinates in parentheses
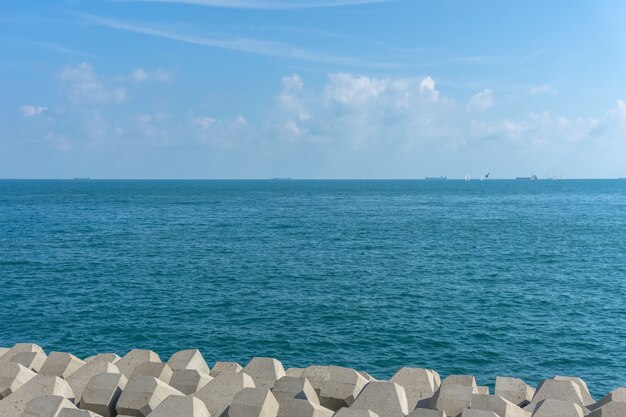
top-left (60, 62), bottom-right (126, 103)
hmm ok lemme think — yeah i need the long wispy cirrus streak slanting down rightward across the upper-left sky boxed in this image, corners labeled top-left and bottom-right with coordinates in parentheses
top-left (81, 14), bottom-right (362, 66)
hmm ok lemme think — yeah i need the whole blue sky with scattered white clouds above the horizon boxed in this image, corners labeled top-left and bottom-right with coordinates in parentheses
top-left (0, 0), bottom-right (626, 179)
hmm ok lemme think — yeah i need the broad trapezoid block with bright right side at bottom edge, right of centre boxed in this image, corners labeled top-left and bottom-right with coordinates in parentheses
top-left (351, 381), bottom-right (409, 417)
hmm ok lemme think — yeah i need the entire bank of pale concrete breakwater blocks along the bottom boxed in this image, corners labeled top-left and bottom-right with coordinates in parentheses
top-left (0, 343), bottom-right (626, 417)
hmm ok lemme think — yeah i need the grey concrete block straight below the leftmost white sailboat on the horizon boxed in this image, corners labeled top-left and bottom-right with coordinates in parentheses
top-left (428, 375), bottom-right (478, 417)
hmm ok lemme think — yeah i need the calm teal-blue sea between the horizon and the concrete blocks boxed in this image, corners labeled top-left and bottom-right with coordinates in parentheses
top-left (0, 180), bottom-right (626, 396)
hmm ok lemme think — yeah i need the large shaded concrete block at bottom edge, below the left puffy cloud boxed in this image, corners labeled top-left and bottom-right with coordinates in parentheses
top-left (79, 372), bottom-right (127, 417)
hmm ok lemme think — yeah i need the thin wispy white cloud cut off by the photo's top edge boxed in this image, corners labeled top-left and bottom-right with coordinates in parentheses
top-left (114, 0), bottom-right (392, 10)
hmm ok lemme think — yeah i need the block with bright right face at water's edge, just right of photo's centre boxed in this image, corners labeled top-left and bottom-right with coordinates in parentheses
top-left (320, 366), bottom-right (367, 411)
